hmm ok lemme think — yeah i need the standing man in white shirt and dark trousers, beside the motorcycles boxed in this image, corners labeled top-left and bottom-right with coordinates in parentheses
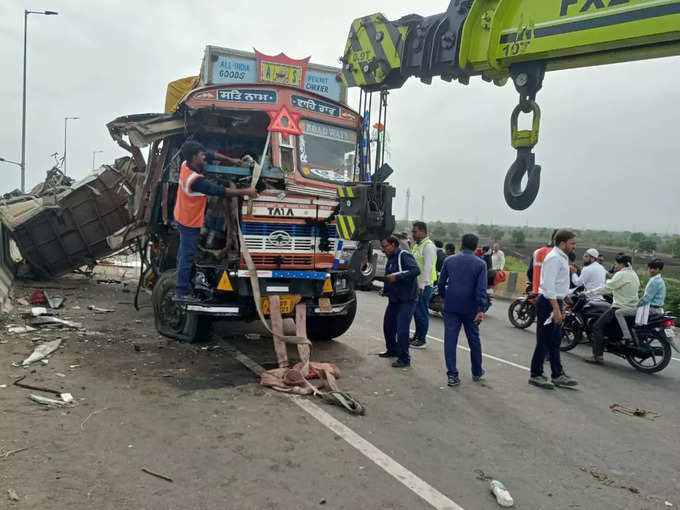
top-left (529, 230), bottom-right (578, 390)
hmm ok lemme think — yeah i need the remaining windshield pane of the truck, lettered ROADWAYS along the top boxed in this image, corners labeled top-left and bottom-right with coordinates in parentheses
top-left (298, 120), bottom-right (357, 183)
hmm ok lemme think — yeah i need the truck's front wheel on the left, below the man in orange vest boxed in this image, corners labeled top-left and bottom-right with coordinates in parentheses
top-left (151, 269), bottom-right (210, 343)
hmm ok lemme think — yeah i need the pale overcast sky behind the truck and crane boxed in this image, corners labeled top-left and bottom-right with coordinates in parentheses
top-left (0, 0), bottom-right (680, 233)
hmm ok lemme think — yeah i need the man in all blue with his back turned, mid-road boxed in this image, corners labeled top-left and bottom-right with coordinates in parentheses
top-left (438, 234), bottom-right (488, 386)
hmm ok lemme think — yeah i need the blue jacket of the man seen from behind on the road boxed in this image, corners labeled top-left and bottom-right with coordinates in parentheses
top-left (437, 250), bottom-right (488, 315)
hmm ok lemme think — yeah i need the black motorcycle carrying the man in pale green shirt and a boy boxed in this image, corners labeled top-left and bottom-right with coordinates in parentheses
top-left (560, 295), bottom-right (680, 374)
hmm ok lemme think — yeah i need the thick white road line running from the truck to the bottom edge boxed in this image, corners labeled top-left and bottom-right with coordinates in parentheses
top-left (229, 347), bottom-right (464, 510)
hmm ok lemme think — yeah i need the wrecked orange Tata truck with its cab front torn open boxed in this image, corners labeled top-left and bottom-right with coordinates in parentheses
top-left (108, 46), bottom-right (394, 342)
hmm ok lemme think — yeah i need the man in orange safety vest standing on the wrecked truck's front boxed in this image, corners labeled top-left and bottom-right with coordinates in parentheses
top-left (174, 141), bottom-right (257, 303)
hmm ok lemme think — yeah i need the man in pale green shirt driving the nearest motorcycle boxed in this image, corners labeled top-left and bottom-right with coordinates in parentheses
top-left (583, 254), bottom-right (640, 365)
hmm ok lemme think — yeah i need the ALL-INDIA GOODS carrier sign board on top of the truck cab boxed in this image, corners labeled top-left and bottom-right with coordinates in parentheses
top-left (201, 46), bottom-right (347, 103)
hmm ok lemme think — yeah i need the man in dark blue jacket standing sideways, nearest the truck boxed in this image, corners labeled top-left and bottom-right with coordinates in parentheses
top-left (379, 236), bottom-right (420, 368)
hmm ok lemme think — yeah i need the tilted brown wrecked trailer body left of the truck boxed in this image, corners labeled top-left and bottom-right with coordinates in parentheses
top-left (0, 157), bottom-right (136, 279)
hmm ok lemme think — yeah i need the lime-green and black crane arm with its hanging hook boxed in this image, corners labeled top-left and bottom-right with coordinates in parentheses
top-left (342, 0), bottom-right (680, 210)
